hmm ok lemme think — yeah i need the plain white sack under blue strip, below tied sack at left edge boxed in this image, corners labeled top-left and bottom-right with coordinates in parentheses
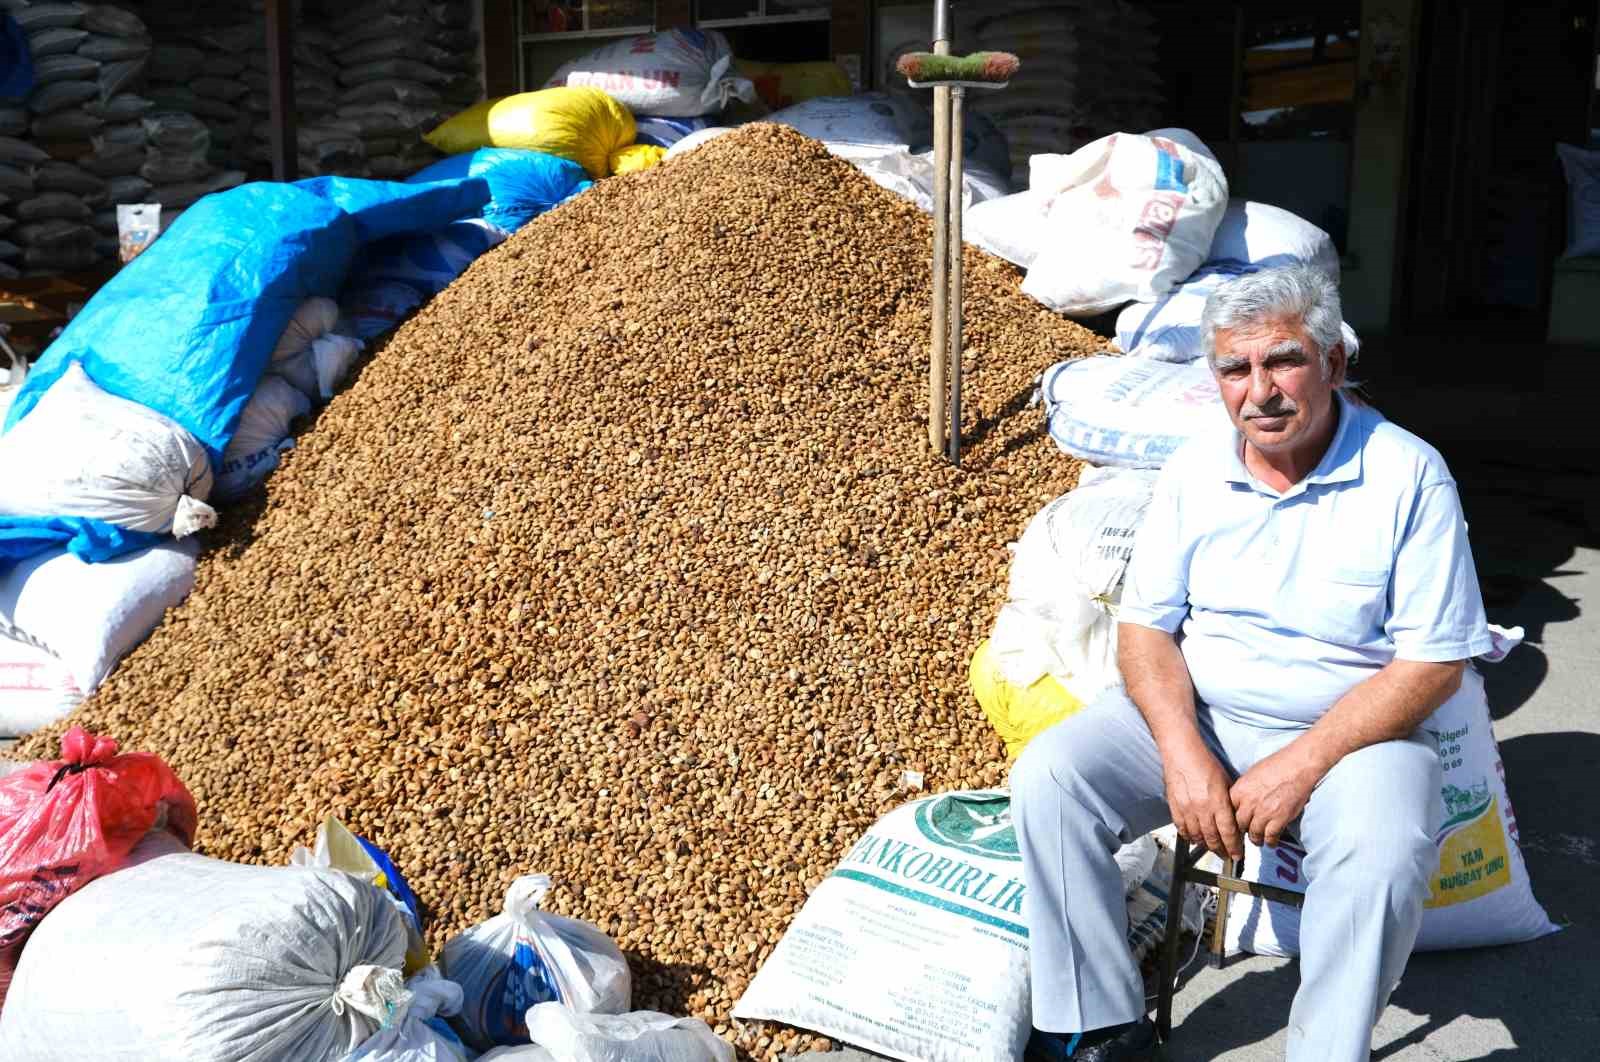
top-left (0, 539), bottom-right (200, 696)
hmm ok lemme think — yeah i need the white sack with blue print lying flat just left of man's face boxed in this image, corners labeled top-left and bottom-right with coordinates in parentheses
top-left (1040, 357), bottom-right (1227, 469)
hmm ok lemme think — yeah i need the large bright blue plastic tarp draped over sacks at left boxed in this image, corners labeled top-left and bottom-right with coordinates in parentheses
top-left (6, 178), bottom-right (490, 469)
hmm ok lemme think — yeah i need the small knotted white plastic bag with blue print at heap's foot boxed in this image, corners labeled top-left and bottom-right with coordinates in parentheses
top-left (438, 873), bottom-right (634, 1051)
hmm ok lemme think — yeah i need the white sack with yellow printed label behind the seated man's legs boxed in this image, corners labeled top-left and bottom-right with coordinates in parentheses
top-left (1227, 667), bottom-right (1557, 955)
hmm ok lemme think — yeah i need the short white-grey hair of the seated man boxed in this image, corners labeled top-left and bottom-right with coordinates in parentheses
top-left (1200, 264), bottom-right (1355, 379)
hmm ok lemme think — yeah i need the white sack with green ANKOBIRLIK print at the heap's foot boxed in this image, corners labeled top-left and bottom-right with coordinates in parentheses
top-left (733, 790), bottom-right (1032, 1062)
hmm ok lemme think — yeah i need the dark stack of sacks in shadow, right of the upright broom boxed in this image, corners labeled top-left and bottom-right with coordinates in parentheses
top-left (947, 0), bottom-right (1165, 186)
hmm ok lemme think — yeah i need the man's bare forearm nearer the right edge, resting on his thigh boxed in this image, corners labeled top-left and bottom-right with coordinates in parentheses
top-left (1294, 661), bottom-right (1466, 777)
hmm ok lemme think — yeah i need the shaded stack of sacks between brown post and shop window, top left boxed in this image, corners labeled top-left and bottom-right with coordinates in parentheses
top-left (323, 0), bottom-right (482, 181)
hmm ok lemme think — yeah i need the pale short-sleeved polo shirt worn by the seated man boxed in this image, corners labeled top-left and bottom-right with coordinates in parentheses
top-left (1117, 393), bottom-right (1491, 728)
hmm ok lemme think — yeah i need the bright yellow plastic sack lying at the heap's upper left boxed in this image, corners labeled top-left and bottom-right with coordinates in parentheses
top-left (422, 86), bottom-right (634, 178)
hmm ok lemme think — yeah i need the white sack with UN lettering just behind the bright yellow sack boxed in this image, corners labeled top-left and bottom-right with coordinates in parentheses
top-left (544, 29), bottom-right (755, 118)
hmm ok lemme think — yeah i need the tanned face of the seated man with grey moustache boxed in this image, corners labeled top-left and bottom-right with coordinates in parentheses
top-left (1211, 317), bottom-right (1344, 454)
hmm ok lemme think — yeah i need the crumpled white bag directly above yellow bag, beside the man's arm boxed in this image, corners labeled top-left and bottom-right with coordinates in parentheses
top-left (989, 470), bottom-right (1155, 704)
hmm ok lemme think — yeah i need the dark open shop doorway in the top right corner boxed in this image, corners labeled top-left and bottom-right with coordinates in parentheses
top-left (1394, 0), bottom-right (1597, 339)
